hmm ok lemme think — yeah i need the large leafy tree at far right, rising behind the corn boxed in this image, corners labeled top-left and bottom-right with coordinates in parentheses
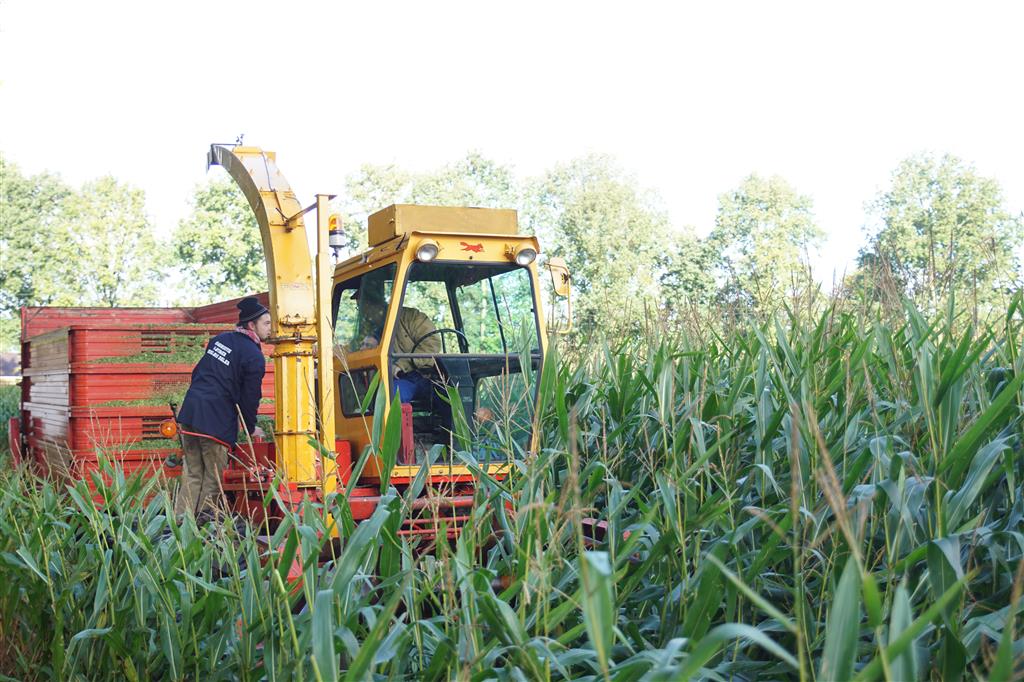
top-left (859, 155), bottom-right (1024, 307)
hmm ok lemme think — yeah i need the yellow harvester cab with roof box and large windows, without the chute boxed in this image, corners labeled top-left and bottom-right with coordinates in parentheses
top-left (332, 205), bottom-right (546, 480)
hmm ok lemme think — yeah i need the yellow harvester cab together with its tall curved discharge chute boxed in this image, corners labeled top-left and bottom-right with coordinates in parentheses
top-left (203, 145), bottom-right (571, 535)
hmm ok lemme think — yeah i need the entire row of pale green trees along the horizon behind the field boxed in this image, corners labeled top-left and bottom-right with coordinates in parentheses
top-left (0, 154), bottom-right (1024, 348)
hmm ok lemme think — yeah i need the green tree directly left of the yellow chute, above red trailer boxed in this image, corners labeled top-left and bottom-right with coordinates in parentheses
top-left (173, 177), bottom-right (267, 300)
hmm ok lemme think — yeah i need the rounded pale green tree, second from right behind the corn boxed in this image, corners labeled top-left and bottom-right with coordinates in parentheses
top-left (708, 174), bottom-right (824, 314)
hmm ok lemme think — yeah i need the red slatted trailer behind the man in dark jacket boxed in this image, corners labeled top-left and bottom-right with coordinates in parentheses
top-left (10, 294), bottom-right (273, 484)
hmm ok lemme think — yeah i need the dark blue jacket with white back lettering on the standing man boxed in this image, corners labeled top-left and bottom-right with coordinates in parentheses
top-left (178, 332), bottom-right (266, 444)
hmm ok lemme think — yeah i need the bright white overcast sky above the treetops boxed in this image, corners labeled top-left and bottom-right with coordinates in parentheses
top-left (0, 0), bottom-right (1024, 281)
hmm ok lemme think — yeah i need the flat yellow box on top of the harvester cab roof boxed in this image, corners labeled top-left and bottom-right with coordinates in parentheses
top-left (368, 204), bottom-right (519, 247)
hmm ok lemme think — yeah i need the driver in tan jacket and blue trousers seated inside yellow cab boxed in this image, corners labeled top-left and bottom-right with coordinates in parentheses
top-left (352, 288), bottom-right (441, 402)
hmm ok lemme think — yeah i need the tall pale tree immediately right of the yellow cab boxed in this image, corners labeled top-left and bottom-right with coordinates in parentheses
top-left (526, 156), bottom-right (676, 335)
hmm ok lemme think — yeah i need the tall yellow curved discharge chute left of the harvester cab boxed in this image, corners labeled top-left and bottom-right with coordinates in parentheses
top-left (207, 144), bottom-right (334, 487)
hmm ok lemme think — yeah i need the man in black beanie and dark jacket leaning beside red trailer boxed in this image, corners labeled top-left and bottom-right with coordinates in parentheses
top-left (174, 296), bottom-right (270, 515)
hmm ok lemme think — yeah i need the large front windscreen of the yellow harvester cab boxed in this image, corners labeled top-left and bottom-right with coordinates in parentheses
top-left (388, 260), bottom-right (543, 464)
